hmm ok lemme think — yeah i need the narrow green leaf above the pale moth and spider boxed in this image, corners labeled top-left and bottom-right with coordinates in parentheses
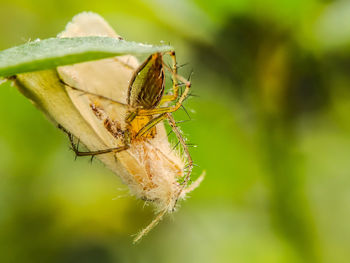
top-left (0, 37), bottom-right (173, 77)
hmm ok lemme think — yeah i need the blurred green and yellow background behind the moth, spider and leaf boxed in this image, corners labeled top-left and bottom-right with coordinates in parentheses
top-left (0, 0), bottom-right (350, 263)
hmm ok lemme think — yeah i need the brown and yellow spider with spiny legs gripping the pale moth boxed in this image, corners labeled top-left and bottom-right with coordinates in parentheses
top-left (59, 51), bottom-right (193, 177)
